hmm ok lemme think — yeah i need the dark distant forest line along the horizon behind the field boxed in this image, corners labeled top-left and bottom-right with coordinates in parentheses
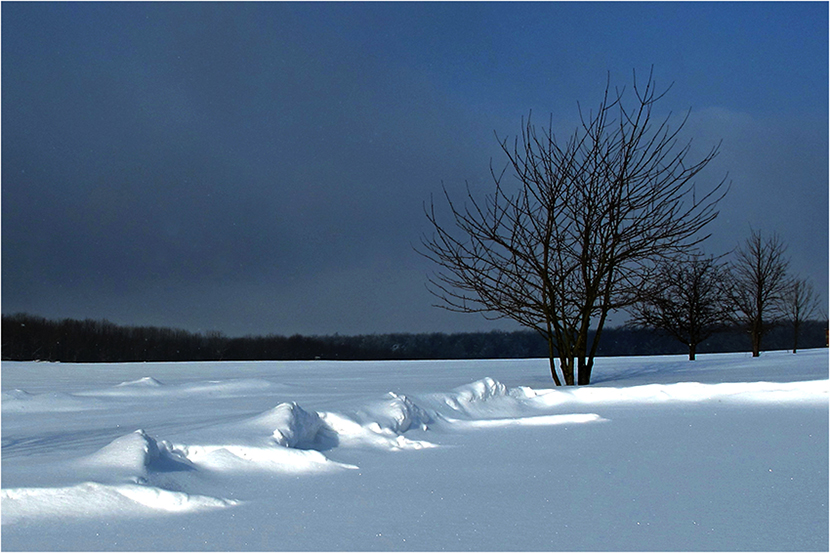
top-left (2, 313), bottom-right (826, 363)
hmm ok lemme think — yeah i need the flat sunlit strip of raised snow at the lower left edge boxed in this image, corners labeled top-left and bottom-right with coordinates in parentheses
top-left (0, 482), bottom-right (240, 525)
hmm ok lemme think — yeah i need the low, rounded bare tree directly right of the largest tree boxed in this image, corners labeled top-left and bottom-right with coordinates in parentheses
top-left (628, 252), bottom-right (731, 361)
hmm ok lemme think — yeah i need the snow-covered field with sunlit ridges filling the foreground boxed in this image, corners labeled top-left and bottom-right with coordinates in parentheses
top-left (0, 350), bottom-right (829, 551)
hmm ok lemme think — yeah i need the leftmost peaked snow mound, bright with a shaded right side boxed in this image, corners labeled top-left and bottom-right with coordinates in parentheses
top-left (81, 429), bottom-right (195, 478)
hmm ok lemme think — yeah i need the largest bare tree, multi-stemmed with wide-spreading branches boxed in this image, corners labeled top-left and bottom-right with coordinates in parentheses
top-left (422, 69), bottom-right (726, 385)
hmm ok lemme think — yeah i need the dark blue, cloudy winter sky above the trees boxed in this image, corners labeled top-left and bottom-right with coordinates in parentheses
top-left (1, 2), bottom-right (828, 336)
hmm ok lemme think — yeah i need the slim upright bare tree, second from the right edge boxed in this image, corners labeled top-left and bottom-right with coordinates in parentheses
top-left (731, 230), bottom-right (789, 357)
